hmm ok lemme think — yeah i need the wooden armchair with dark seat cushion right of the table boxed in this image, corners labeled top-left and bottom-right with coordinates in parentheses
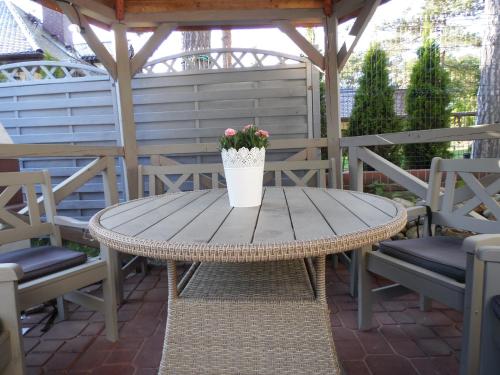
top-left (358, 158), bottom-right (500, 375)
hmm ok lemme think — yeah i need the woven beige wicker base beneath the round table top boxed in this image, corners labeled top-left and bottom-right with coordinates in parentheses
top-left (160, 260), bottom-right (340, 375)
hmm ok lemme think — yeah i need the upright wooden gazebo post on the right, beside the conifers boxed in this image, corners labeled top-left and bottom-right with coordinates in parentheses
top-left (325, 13), bottom-right (342, 189)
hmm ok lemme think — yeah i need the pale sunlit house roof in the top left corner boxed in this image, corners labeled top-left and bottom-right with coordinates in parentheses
top-left (0, 0), bottom-right (78, 61)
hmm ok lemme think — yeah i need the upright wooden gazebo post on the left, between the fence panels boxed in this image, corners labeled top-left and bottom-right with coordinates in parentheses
top-left (113, 23), bottom-right (138, 203)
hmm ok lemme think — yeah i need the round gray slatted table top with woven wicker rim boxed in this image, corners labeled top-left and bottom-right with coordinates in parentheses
top-left (90, 187), bottom-right (406, 261)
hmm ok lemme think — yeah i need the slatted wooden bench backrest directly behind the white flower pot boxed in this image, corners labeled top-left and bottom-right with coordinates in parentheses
top-left (138, 160), bottom-right (331, 197)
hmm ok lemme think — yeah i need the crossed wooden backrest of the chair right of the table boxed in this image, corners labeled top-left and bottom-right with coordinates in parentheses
top-left (426, 158), bottom-right (500, 233)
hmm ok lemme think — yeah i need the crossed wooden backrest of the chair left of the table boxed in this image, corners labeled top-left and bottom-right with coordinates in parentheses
top-left (0, 171), bottom-right (61, 246)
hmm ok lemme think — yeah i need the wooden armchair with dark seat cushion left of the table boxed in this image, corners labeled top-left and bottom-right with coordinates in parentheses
top-left (0, 171), bottom-right (118, 374)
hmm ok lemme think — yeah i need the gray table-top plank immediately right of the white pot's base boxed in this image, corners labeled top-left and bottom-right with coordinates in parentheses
top-left (253, 188), bottom-right (295, 243)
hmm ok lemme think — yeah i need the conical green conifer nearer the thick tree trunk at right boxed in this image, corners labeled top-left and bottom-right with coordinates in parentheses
top-left (404, 39), bottom-right (451, 169)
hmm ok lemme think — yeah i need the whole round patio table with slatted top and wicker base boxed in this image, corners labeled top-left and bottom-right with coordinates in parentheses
top-left (89, 187), bottom-right (406, 374)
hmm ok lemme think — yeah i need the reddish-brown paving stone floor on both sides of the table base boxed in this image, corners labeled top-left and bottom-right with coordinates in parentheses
top-left (24, 265), bottom-right (462, 375)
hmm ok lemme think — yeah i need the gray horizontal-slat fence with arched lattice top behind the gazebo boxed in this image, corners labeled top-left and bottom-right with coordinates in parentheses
top-left (0, 49), bottom-right (320, 218)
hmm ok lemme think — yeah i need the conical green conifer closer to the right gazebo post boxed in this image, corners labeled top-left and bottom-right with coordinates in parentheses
top-left (347, 44), bottom-right (401, 164)
